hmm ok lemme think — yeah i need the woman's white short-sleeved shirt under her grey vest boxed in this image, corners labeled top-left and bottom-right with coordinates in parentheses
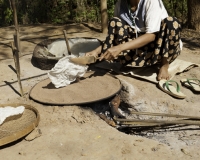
top-left (114, 0), bottom-right (168, 33)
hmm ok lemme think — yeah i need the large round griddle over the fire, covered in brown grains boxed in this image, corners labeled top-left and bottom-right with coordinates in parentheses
top-left (29, 72), bottom-right (122, 105)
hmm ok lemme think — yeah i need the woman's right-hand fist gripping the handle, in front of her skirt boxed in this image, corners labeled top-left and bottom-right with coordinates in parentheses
top-left (99, 46), bottom-right (121, 61)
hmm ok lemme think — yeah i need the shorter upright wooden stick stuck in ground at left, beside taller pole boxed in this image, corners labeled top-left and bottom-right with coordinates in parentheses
top-left (11, 42), bottom-right (24, 97)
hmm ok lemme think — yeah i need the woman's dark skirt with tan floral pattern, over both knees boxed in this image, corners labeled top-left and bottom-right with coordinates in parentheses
top-left (101, 17), bottom-right (181, 67)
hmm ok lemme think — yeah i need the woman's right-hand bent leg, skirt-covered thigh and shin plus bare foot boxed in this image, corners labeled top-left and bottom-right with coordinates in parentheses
top-left (117, 17), bottom-right (181, 80)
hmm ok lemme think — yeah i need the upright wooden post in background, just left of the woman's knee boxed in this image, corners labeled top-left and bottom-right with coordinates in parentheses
top-left (101, 0), bottom-right (108, 33)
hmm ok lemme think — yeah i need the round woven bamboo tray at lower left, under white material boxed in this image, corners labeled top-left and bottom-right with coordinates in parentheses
top-left (0, 104), bottom-right (40, 146)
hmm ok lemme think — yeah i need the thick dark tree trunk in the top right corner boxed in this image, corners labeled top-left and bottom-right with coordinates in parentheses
top-left (188, 0), bottom-right (200, 31)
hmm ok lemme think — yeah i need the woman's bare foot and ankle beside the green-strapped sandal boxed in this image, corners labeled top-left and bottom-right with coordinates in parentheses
top-left (157, 58), bottom-right (169, 81)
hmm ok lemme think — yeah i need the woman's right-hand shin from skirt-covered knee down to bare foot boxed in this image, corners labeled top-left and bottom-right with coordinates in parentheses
top-left (156, 17), bottom-right (181, 80)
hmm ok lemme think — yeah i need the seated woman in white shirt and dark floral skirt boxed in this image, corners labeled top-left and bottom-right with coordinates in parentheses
top-left (86, 0), bottom-right (181, 80)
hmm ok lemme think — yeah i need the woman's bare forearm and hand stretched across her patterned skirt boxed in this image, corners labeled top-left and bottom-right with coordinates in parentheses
top-left (100, 33), bottom-right (156, 60)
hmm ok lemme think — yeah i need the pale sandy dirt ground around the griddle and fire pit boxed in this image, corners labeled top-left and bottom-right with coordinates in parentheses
top-left (0, 24), bottom-right (200, 160)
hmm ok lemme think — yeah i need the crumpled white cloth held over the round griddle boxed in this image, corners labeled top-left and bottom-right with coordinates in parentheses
top-left (48, 55), bottom-right (88, 88)
